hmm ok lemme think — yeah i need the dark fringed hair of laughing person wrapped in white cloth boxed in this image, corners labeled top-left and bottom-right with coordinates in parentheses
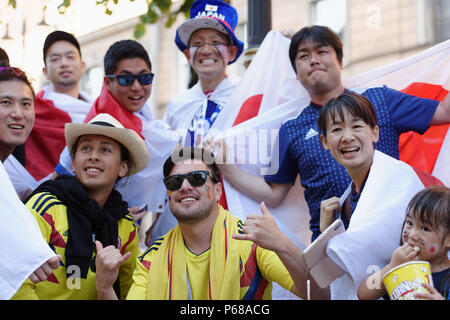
top-left (318, 91), bottom-right (378, 137)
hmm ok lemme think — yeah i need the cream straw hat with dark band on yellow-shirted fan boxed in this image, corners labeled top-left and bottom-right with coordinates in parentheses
top-left (65, 113), bottom-right (149, 176)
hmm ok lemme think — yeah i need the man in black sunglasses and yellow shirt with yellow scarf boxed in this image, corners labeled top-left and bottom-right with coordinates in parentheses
top-left (96, 147), bottom-right (320, 300)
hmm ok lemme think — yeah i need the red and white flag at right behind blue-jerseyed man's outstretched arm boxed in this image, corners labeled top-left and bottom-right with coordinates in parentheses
top-left (344, 40), bottom-right (450, 185)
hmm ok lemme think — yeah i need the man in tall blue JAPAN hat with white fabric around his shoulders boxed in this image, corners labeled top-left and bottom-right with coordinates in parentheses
top-left (151, 0), bottom-right (244, 245)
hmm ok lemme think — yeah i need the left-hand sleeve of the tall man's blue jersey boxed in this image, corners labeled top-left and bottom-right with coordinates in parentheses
top-left (264, 125), bottom-right (298, 184)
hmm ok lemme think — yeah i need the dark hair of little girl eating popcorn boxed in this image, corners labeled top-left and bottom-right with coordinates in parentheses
top-left (406, 186), bottom-right (450, 238)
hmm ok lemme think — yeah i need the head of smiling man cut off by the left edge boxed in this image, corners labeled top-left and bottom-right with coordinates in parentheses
top-left (0, 67), bottom-right (35, 162)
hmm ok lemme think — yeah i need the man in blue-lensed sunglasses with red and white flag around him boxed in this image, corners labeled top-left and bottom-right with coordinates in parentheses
top-left (56, 40), bottom-right (179, 231)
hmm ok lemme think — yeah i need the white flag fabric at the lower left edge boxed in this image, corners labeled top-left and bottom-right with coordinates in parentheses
top-left (0, 161), bottom-right (55, 300)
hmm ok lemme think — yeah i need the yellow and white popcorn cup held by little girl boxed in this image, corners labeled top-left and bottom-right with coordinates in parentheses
top-left (383, 261), bottom-right (433, 300)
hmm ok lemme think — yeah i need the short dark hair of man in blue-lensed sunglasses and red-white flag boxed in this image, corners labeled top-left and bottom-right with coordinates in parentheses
top-left (103, 40), bottom-right (152, 75)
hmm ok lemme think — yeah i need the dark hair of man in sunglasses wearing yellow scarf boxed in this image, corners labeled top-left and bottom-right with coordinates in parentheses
top-left (163, 147), bottom-right (220, 183)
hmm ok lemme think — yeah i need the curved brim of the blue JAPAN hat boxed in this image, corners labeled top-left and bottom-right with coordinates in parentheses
top-left (175, 17), bottom-right (244, 64)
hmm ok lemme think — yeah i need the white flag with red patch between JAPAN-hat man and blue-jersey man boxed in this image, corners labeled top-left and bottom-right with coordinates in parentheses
top-left (208, 31), bottom-right (311, 247)
